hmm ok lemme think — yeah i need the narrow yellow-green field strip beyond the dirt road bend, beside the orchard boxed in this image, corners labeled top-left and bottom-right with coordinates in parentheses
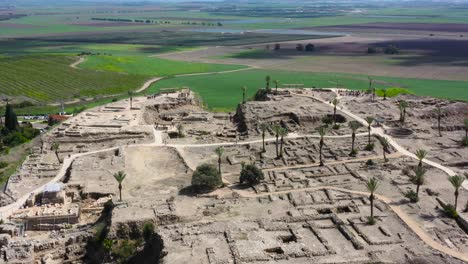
top-left (80, 55), bottom-right (245, 76)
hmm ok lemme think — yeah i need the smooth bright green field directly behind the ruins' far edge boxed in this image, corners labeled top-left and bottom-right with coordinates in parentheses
top-left (148, 70), bottom-right (468, 111)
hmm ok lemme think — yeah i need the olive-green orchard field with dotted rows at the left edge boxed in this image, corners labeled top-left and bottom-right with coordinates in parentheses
top-left (0, 55), bottom-right (148, 103)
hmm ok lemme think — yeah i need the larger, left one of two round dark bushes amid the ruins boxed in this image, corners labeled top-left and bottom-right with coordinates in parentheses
top-left (192, 164), bottom-right (223, 191)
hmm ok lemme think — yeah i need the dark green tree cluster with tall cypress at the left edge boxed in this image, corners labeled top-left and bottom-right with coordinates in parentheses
top-left (0, 103), bottom-right (40, 152)
